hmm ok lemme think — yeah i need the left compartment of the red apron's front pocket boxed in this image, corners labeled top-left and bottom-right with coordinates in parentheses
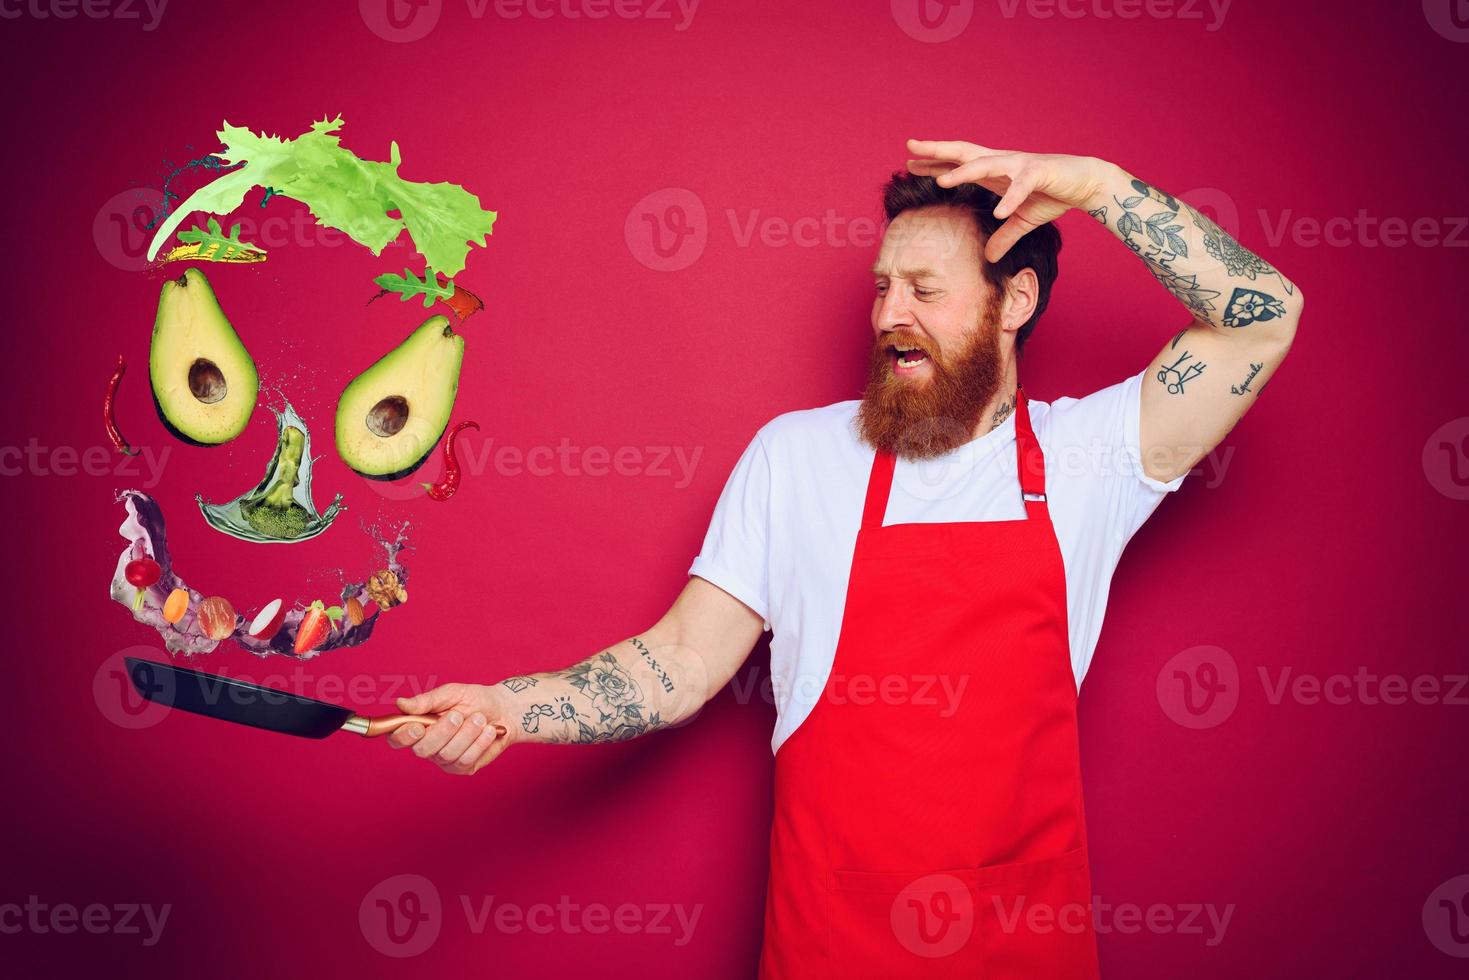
top-left (826, 867), bottom-right (983, 980)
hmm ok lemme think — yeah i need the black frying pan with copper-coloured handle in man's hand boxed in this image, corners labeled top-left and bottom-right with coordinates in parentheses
top-left (123, 657), bottom-right (505, 739)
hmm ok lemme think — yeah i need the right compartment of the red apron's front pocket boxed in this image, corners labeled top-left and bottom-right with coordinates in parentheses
top-left (972, 846), bottom-right (1097, 980)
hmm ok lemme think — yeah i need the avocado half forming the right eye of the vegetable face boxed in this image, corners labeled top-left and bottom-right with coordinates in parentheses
top-left (336, 316), bottom-right (464, 480)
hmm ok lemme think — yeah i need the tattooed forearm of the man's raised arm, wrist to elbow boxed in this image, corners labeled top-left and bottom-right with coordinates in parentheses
top-left (1087, 170), bottom-right (1299, 329)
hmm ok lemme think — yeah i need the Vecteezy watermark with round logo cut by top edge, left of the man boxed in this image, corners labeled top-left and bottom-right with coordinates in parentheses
top-left (357, 0), bottom-right (699, 44)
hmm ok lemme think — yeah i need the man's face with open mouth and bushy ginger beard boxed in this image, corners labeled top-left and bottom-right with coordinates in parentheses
top-left (858, 207), bottom-right (1005, 458)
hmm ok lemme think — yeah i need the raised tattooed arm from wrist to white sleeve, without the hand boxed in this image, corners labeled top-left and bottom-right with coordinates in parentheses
top-left (1083, 162), bottom-right (1304, 482)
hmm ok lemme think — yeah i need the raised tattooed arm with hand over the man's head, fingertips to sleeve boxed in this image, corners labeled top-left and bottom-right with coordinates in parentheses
top-left (908, 140), bottom-right (1304, 482)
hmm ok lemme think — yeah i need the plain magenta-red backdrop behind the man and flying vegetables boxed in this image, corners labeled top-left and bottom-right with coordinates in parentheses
top-left (0, 0), bottom-right (1469, 979)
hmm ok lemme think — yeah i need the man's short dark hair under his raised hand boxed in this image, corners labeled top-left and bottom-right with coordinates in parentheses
top-left (883, 170), bottom-right (1061, 354)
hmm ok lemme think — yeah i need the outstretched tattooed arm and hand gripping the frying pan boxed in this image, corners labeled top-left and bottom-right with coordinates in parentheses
top-left (388, 576), bottom-right (764, 776)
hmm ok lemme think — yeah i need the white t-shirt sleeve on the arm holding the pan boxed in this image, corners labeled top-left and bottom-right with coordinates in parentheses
top-left (689, 433), bottom-right (770, 630)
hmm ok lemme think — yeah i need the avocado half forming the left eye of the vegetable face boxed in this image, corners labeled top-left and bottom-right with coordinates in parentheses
top-left (148, 269), bottom-right (260, 445)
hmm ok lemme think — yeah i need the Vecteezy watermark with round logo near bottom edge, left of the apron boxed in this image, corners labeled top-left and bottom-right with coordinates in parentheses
top-left (357, 874), bottom-right (704, 958)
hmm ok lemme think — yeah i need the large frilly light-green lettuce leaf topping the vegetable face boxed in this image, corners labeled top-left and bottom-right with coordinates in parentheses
top-left (148, 116), bottom-right (497, 276)
